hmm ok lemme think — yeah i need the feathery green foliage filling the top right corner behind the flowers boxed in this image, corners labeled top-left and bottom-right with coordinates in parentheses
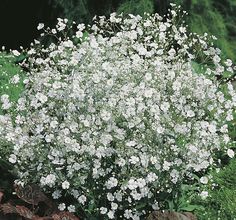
top-left (176, 0), bottom-right (236, 61)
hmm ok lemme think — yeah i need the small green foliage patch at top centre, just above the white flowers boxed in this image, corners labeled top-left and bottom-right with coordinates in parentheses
top-left (117, 0), bottom-right (154, 15)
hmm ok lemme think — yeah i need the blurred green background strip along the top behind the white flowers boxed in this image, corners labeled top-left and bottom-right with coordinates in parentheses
top-left (50, 0), bottom-right (236, 61)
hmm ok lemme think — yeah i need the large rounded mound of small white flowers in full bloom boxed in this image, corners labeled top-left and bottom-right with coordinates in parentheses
top-left (0, 6), bottom-right (236, 220)
